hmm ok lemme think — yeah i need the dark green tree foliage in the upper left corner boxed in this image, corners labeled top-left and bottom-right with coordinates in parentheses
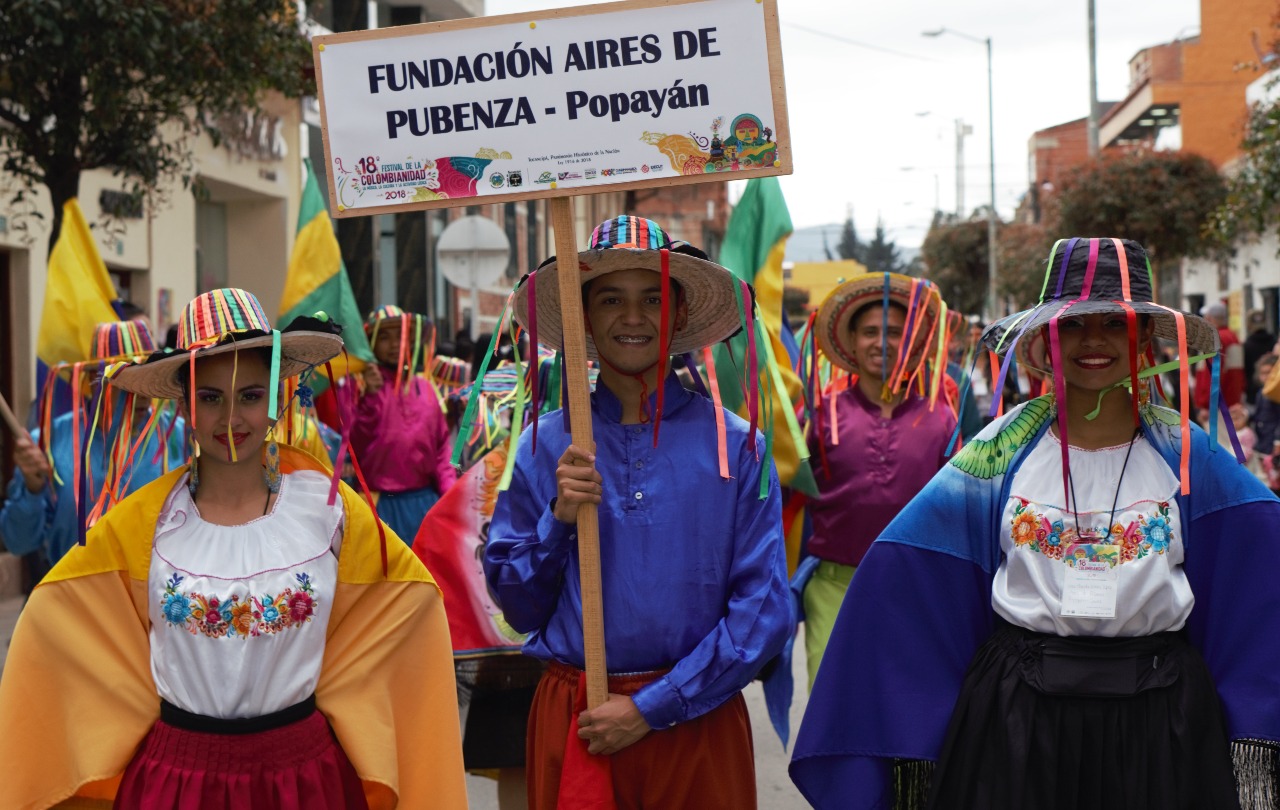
top-left (0, 0), bottom-right (315, 244)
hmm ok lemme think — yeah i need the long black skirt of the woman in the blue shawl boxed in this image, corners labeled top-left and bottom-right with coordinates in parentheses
top-left (929, 624), bottom-right (1239, 810)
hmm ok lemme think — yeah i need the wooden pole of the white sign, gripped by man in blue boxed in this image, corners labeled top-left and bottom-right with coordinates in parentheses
top-left (550, 197), bottom-right (609, 709)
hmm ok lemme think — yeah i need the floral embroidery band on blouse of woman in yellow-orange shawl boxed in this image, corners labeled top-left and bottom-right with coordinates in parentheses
top-left (160, 573), bottom-right (316, 639)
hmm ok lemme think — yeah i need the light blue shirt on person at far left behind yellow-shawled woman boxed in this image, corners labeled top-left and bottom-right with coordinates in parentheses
top-left (0, 413), bottom-right (187, 566)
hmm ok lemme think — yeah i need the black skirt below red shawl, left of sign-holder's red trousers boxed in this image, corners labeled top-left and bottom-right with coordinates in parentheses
top-left (453, 654), bottom-right (547, 770)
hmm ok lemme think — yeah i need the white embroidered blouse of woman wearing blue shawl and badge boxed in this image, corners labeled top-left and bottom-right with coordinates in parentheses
top-left (992, 430), bottom-right (1196, 636)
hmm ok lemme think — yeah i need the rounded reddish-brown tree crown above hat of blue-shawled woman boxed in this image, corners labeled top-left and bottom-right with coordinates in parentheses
top-left (1056, 152), bottom-right (1226, 255)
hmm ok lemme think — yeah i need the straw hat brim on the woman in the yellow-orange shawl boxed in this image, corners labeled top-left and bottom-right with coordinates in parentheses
top-left (111, 330), bottom-right (342, 399)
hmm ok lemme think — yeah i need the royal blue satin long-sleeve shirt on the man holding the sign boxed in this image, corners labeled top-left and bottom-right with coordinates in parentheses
top-left (484, 374), bottom-right (790, 728)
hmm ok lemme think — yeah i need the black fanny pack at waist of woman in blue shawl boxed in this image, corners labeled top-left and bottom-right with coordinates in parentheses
top-left (1015, 631), bottom-right (1187, 697)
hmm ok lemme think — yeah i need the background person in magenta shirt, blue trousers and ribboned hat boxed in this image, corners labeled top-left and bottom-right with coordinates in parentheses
top-left (340, 306), bottom-right (458, 543)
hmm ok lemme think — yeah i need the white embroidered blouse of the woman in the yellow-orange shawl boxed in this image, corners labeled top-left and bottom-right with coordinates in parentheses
top-left (147, 471), bottom-right (342, 719)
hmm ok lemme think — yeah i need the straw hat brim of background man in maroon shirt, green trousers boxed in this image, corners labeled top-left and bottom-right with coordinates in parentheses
top-left (814, 273), bottom-right (941, 374)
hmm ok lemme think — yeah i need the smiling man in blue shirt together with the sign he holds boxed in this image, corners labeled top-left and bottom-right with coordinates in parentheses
top-left (314, 0), bottom-right (791, 809)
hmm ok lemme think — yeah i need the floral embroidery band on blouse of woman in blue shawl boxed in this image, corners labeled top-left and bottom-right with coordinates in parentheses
top-left (1009, 495), bottom-right (1174, 566)
